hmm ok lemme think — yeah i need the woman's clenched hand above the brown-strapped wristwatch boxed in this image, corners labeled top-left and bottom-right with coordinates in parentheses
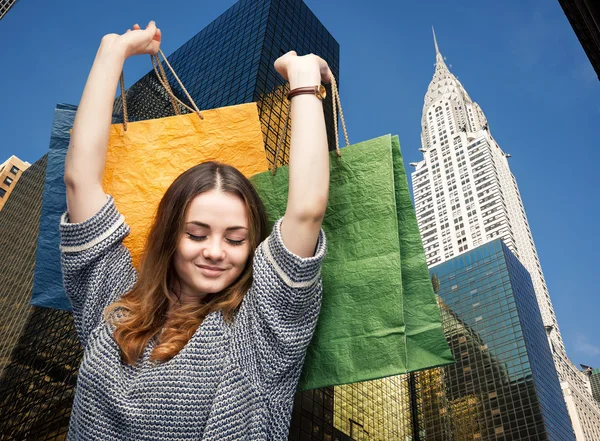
top-left (275, 51), bottom-right (333, 89)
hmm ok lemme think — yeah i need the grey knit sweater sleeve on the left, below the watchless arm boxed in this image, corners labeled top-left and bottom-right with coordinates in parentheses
top-left (60, 196), bottom-right (137, 347)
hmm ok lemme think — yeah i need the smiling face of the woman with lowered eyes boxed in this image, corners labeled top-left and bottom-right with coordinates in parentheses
top-left (174, 190), bottom-right (250, 304)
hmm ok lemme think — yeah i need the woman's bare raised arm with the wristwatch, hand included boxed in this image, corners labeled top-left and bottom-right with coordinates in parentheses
top-left (275, 52), bottom-right (331, 257)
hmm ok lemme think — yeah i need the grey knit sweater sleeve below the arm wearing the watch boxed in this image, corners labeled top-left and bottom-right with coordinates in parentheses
top-left (232, 219), bottom-right (327, 392)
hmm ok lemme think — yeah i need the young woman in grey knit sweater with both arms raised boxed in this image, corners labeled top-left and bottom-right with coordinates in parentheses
top-left (60, 22), bottom-right (331, 441)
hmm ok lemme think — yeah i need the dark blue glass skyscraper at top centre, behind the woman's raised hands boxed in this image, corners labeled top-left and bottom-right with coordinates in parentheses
top-left (114, 0), bottom-right (339, 166)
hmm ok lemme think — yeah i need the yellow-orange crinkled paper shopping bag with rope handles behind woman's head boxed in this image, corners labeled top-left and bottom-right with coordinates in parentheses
top-left (103, 51), bottom-right (268, 267)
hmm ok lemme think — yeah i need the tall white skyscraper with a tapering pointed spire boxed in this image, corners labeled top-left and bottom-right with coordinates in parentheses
top-left (412, 34), bottom-right (600, 441)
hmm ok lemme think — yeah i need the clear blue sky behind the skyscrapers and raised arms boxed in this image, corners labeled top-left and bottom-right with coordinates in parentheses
top-left (0, 0), bottom-right (600, 367)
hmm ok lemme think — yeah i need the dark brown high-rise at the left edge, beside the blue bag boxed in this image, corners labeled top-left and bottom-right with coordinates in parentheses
top-left (0, 155), bottom-right (82, 441)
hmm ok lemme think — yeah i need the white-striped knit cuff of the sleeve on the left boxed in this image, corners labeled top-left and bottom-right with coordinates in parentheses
top-left (60, 195), bottom-right (125, 253)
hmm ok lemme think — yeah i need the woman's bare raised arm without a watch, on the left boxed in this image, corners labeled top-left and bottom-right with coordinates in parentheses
top-left (65, 22), bottom-right (161, 223)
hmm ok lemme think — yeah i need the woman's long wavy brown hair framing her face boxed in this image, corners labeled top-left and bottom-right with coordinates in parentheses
top-left (105, 162), bottom-right (268, 365)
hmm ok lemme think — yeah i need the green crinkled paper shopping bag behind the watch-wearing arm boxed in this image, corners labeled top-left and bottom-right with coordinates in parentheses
top-left (252, 135), bottom-right (454, 390)
